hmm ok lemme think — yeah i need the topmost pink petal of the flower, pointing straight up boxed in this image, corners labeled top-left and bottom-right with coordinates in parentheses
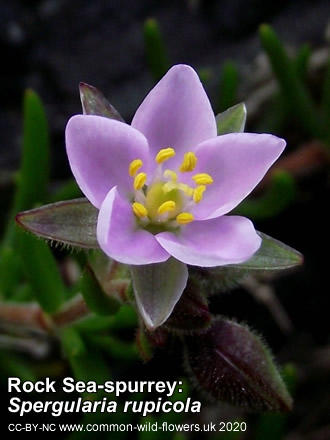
top-left (132, 64), bottom-right (217, 168)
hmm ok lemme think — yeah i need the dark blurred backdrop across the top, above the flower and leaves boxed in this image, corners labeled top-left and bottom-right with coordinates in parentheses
top-left (0, 0), bottom-right (330, 177)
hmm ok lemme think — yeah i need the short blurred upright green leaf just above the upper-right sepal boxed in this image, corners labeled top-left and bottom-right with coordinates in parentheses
top-left (219, 61), bottom-right (238, 111)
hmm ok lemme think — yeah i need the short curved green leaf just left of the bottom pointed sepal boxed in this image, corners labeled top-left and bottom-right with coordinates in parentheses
top-left (80, 266), bottom-right (120, 316)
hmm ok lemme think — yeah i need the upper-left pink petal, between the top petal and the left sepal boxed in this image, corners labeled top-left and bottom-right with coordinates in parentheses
top-left (66, 115), bottom-right (148, 208)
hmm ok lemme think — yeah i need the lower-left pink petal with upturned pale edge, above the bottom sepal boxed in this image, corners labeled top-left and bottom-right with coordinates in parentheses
top-left (96, 187), bottom-right (169, 264)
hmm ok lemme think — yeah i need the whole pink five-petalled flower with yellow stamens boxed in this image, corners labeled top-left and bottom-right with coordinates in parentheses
top-left (66, 65), bottom-right (285, 326)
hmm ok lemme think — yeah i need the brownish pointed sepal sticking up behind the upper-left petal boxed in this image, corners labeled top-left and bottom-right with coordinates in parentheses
top-left (79, 83), bottom-right (124, 122)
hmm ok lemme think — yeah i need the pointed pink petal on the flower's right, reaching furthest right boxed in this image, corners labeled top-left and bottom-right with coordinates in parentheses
top-left (188, 133), bottom-right (285, 219)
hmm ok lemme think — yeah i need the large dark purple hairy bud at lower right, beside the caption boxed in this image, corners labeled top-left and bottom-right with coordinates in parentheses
top-left (185, 318), bottom-right (292, 411)
